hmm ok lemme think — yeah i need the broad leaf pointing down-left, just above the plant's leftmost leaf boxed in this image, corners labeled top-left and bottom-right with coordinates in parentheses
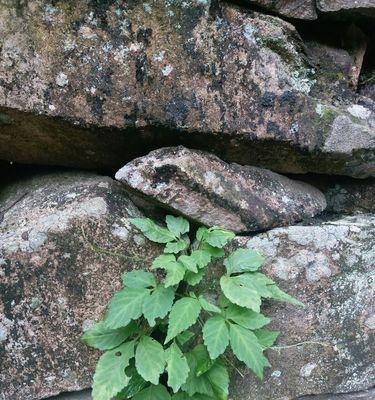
top-left (104, 288), bottom-right (150, 329)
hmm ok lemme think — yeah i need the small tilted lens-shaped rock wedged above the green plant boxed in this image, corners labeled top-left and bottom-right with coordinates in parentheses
top-left (116, 146), bottom-right (326, 232)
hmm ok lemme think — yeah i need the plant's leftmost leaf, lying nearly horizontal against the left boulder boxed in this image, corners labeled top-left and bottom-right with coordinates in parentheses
top-left (81, 321), bottom-right (137, 350)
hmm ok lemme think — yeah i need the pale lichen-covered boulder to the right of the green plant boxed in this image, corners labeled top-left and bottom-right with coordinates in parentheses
top-left (231, 215), bottom-right (375, 400)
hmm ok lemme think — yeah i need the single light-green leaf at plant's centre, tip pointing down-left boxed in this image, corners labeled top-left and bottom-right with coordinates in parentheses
top-left (165, 297), bottom-right (201, 343)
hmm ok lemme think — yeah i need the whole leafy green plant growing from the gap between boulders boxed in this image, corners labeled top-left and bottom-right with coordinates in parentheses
top-left (82, 216), bottom-right (302, 400)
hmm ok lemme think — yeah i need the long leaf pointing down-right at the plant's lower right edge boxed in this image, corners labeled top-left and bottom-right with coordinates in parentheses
top-left (229, 324), bottom-right (271, 379)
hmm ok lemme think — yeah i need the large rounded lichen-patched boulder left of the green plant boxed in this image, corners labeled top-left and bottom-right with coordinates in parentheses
top-left (0, 173), bottom-right (157, 400)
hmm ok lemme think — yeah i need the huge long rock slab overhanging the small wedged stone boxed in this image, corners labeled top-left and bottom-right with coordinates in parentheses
top-left (0, 0), bottom-right (375, 177)
